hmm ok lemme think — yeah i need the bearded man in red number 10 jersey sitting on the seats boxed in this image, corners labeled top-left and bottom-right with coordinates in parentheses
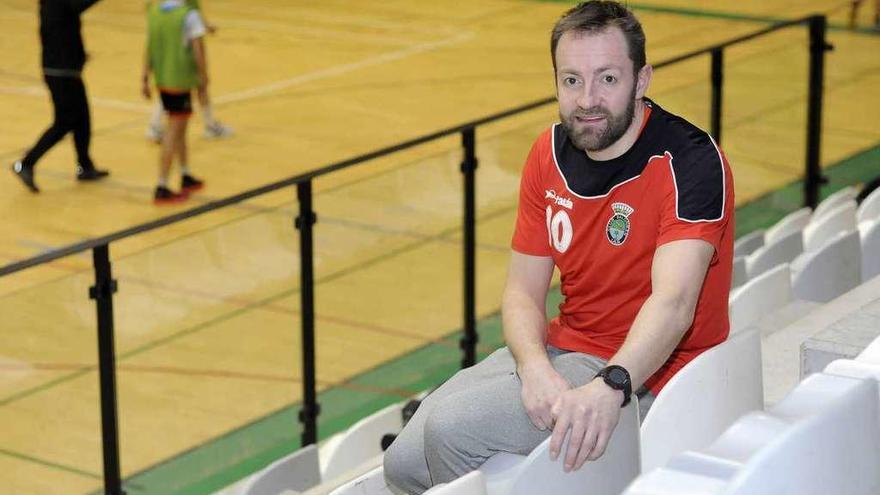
top-left (385, 1), bottom-right (734, 493)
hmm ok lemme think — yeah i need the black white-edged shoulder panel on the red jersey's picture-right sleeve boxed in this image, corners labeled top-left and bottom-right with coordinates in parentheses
top-left (666, 113), bottom-right (726, 222)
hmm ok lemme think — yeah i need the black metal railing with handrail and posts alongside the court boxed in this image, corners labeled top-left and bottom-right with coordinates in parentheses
top-left (0, 15), bottom-right (831, 495)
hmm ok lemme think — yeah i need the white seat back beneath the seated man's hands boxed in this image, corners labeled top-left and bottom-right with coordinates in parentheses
top-left (480, 400), bottom-right (639, 495)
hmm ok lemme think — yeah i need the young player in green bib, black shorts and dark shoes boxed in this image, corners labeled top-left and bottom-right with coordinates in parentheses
top-left (142, 0), bottom-right (208, 204)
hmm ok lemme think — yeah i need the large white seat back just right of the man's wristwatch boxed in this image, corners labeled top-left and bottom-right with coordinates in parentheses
top-left (641, 329), bottom-right (764, 472)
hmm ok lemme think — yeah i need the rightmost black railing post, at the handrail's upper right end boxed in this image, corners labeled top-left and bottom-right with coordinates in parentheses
top-left (804, 15), bottom-right (831, 208)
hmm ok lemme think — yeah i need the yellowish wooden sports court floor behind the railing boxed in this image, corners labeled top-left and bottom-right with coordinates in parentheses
top-left (0, 0), bottom-right (880, 495)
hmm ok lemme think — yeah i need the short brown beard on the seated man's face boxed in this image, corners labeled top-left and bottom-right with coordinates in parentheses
top-left (559, 87), bottom-right (636, 151)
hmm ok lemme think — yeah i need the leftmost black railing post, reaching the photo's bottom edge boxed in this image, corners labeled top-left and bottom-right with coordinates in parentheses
top-left (89, 244), bottom-right (125, 495)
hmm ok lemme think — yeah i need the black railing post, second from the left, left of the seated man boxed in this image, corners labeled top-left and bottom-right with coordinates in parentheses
top-left (295, 180), bottom-right (321, 446)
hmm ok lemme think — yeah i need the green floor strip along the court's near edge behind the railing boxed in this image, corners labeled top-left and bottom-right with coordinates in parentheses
top-left (103, 145), bottom-right (880, 495)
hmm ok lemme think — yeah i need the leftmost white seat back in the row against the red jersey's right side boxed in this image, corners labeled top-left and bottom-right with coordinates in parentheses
top-left (729, 263), bottom-right (793, 333)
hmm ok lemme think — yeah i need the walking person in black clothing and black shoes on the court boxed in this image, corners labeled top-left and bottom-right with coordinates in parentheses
top-left (12, 0), bottom-right (109, 193)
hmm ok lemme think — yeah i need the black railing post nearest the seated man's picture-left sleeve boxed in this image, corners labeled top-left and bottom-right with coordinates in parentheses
top-left (459, 127), bottom-right (479, 368)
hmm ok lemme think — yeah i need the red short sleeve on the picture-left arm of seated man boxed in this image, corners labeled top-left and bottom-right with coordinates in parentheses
top-left (511, 131), bottom-right (551, 256)
